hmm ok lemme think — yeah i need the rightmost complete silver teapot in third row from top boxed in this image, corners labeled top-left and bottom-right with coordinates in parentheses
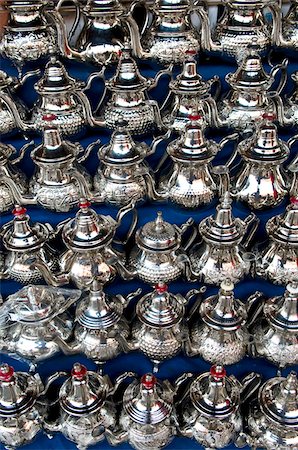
top-left (227, 113), bottom-right (291, 209)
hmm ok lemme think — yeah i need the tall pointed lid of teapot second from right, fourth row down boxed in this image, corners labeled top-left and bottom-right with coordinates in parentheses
top-left (199, 192), bottom-right (246, 244)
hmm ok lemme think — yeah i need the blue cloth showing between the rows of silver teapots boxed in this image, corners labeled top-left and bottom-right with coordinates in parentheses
top-left (0, 47), bottom-right (298, 450)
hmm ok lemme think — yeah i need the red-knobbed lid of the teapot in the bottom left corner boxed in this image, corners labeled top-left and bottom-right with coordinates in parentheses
top-left (0, 364), bottom-right (38, 418)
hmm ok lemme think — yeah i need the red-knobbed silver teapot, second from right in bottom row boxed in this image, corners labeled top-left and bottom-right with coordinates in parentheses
top-left (177, 364), bottom-right (261, 450)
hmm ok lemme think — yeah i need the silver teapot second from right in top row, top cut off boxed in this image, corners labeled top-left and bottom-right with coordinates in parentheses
top-left (205, 0), bottom-right (280, 59)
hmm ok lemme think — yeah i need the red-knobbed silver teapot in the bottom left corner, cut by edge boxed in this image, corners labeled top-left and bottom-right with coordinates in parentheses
top-left (0, 364), bottom-right (48, 450)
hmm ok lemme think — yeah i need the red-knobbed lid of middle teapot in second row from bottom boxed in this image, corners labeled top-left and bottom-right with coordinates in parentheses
top-left (136, 283), bottom-right (185, 328)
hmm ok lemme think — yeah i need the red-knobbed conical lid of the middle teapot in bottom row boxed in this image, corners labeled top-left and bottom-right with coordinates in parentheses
top-left (123, 373), bottom-right (173, 425)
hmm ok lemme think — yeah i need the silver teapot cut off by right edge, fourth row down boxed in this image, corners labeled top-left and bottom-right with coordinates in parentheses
top-left (256, 198), bottom-right (298, 284)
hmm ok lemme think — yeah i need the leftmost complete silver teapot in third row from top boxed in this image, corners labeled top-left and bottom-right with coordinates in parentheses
top-left (29, 125), bottom-right (100, 212)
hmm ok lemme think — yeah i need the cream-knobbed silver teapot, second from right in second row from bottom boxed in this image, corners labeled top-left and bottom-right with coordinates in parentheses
top-left (185, 279), bottom-right (262, 366)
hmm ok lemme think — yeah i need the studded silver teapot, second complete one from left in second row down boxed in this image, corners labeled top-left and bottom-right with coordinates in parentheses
top-left (93, 43), bottom-right (171, 135)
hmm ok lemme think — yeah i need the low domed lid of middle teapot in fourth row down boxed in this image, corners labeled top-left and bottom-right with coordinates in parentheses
top-left (136, 211), bottom-right (181, 251)
